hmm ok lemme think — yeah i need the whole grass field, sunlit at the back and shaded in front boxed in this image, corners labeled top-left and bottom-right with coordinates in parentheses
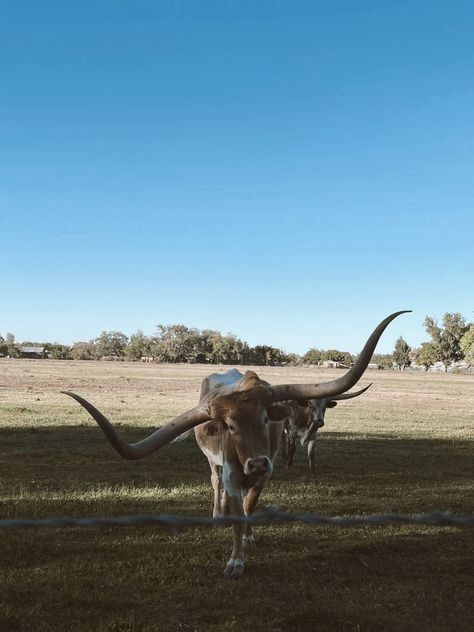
top-left (0, 359), bottom-right (474, 632)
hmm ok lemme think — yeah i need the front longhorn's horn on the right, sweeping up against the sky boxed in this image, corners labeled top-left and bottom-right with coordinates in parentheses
top-left (271, 309), bottom-right (411, 402)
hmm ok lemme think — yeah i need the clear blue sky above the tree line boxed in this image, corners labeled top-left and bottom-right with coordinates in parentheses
top-left (0, 0), bottom-right (474, 353)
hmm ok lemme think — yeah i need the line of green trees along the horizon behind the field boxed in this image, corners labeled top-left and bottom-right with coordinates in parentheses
top-left (0, 313), bottom-right (474, 370)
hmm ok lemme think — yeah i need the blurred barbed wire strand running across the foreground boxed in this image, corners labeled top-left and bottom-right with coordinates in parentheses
top-left (0, 507), bottom-right (474, 532)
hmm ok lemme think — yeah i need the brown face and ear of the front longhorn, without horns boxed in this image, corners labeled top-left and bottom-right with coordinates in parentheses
top-left (212, 388), bottom-right (290, 478)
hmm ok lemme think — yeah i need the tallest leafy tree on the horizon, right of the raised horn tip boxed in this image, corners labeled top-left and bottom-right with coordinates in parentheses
top-left (424, 312), bottom-right (469, 371)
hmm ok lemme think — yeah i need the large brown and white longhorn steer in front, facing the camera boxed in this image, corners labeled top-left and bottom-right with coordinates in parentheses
top-left (60, 312), bottom-right (404, 579)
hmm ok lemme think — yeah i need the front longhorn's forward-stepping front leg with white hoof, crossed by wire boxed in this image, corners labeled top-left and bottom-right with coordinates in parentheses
top-left (223, 464), bottom-right (246, 579)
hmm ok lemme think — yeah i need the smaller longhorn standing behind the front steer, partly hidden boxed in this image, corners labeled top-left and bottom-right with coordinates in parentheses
top-left (281, 384), bottom-right (372, 474)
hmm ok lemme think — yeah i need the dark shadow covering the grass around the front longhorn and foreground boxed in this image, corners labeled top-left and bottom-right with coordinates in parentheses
top-left (0, 426), bottom-right (473, 632)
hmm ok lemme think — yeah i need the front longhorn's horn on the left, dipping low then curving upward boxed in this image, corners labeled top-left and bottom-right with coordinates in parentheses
top-left (61, 391), bottom-right (211, 460)
